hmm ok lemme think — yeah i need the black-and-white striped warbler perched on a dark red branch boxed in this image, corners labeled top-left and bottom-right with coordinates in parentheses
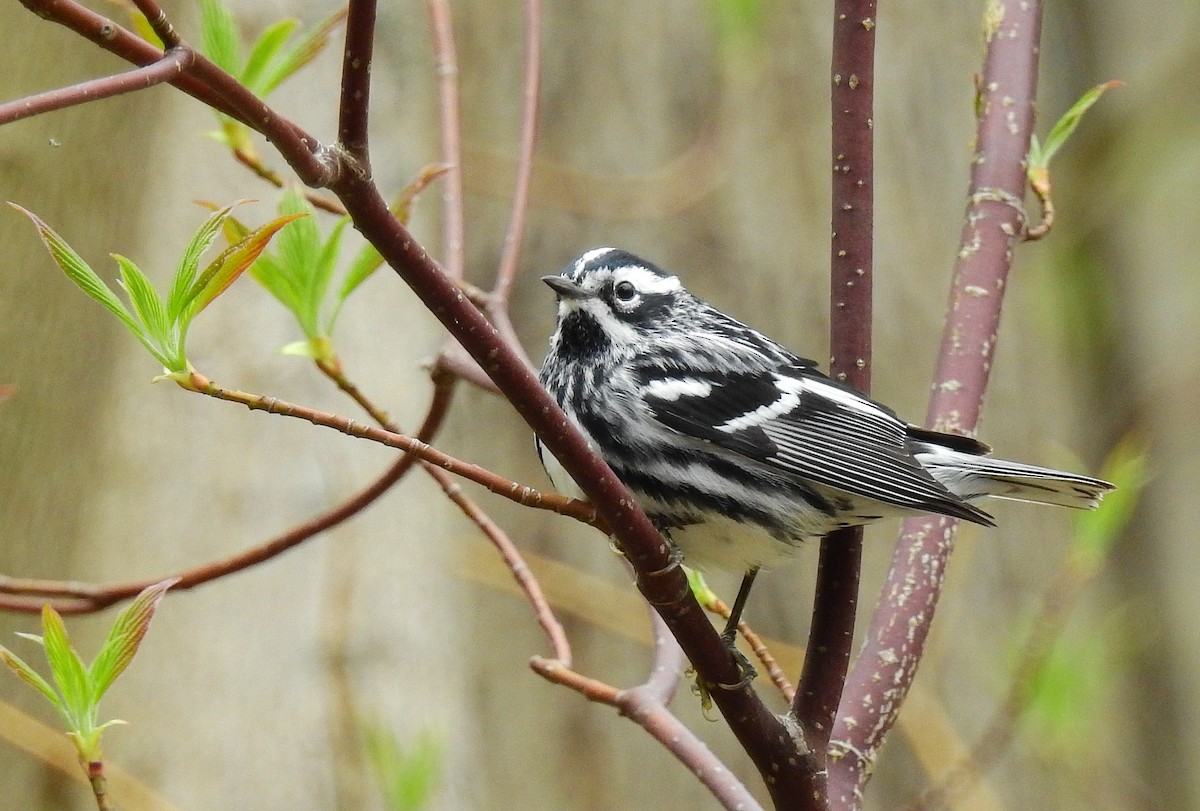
top-left (536, 247), bottom-right (1114, 638)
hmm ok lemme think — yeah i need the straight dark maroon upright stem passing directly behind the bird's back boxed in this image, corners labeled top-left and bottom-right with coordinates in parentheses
top-left (792, 0), bottom-right (876, 762)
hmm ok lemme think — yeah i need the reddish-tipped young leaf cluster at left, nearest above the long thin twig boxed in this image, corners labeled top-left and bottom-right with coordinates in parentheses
top-left (10, 202), bottom-right (302, 376)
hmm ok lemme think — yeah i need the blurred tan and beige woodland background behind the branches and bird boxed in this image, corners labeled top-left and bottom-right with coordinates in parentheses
top-left (0, 0), bottom-right (1200, 811)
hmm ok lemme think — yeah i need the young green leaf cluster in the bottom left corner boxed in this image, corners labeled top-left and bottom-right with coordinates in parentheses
top-left (0, 578), bottom-right (179, 763)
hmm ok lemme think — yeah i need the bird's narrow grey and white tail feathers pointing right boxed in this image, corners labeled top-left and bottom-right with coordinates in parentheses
top-left (917, 445), bottom-right (1115, 510)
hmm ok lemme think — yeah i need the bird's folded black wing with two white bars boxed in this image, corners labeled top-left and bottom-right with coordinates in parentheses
top-left (638, 364), bottom-right (990, 523)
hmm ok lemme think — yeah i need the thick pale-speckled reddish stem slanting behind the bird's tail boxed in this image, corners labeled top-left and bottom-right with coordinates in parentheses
top-left (829, 0), bottom-right (1042, 807)
